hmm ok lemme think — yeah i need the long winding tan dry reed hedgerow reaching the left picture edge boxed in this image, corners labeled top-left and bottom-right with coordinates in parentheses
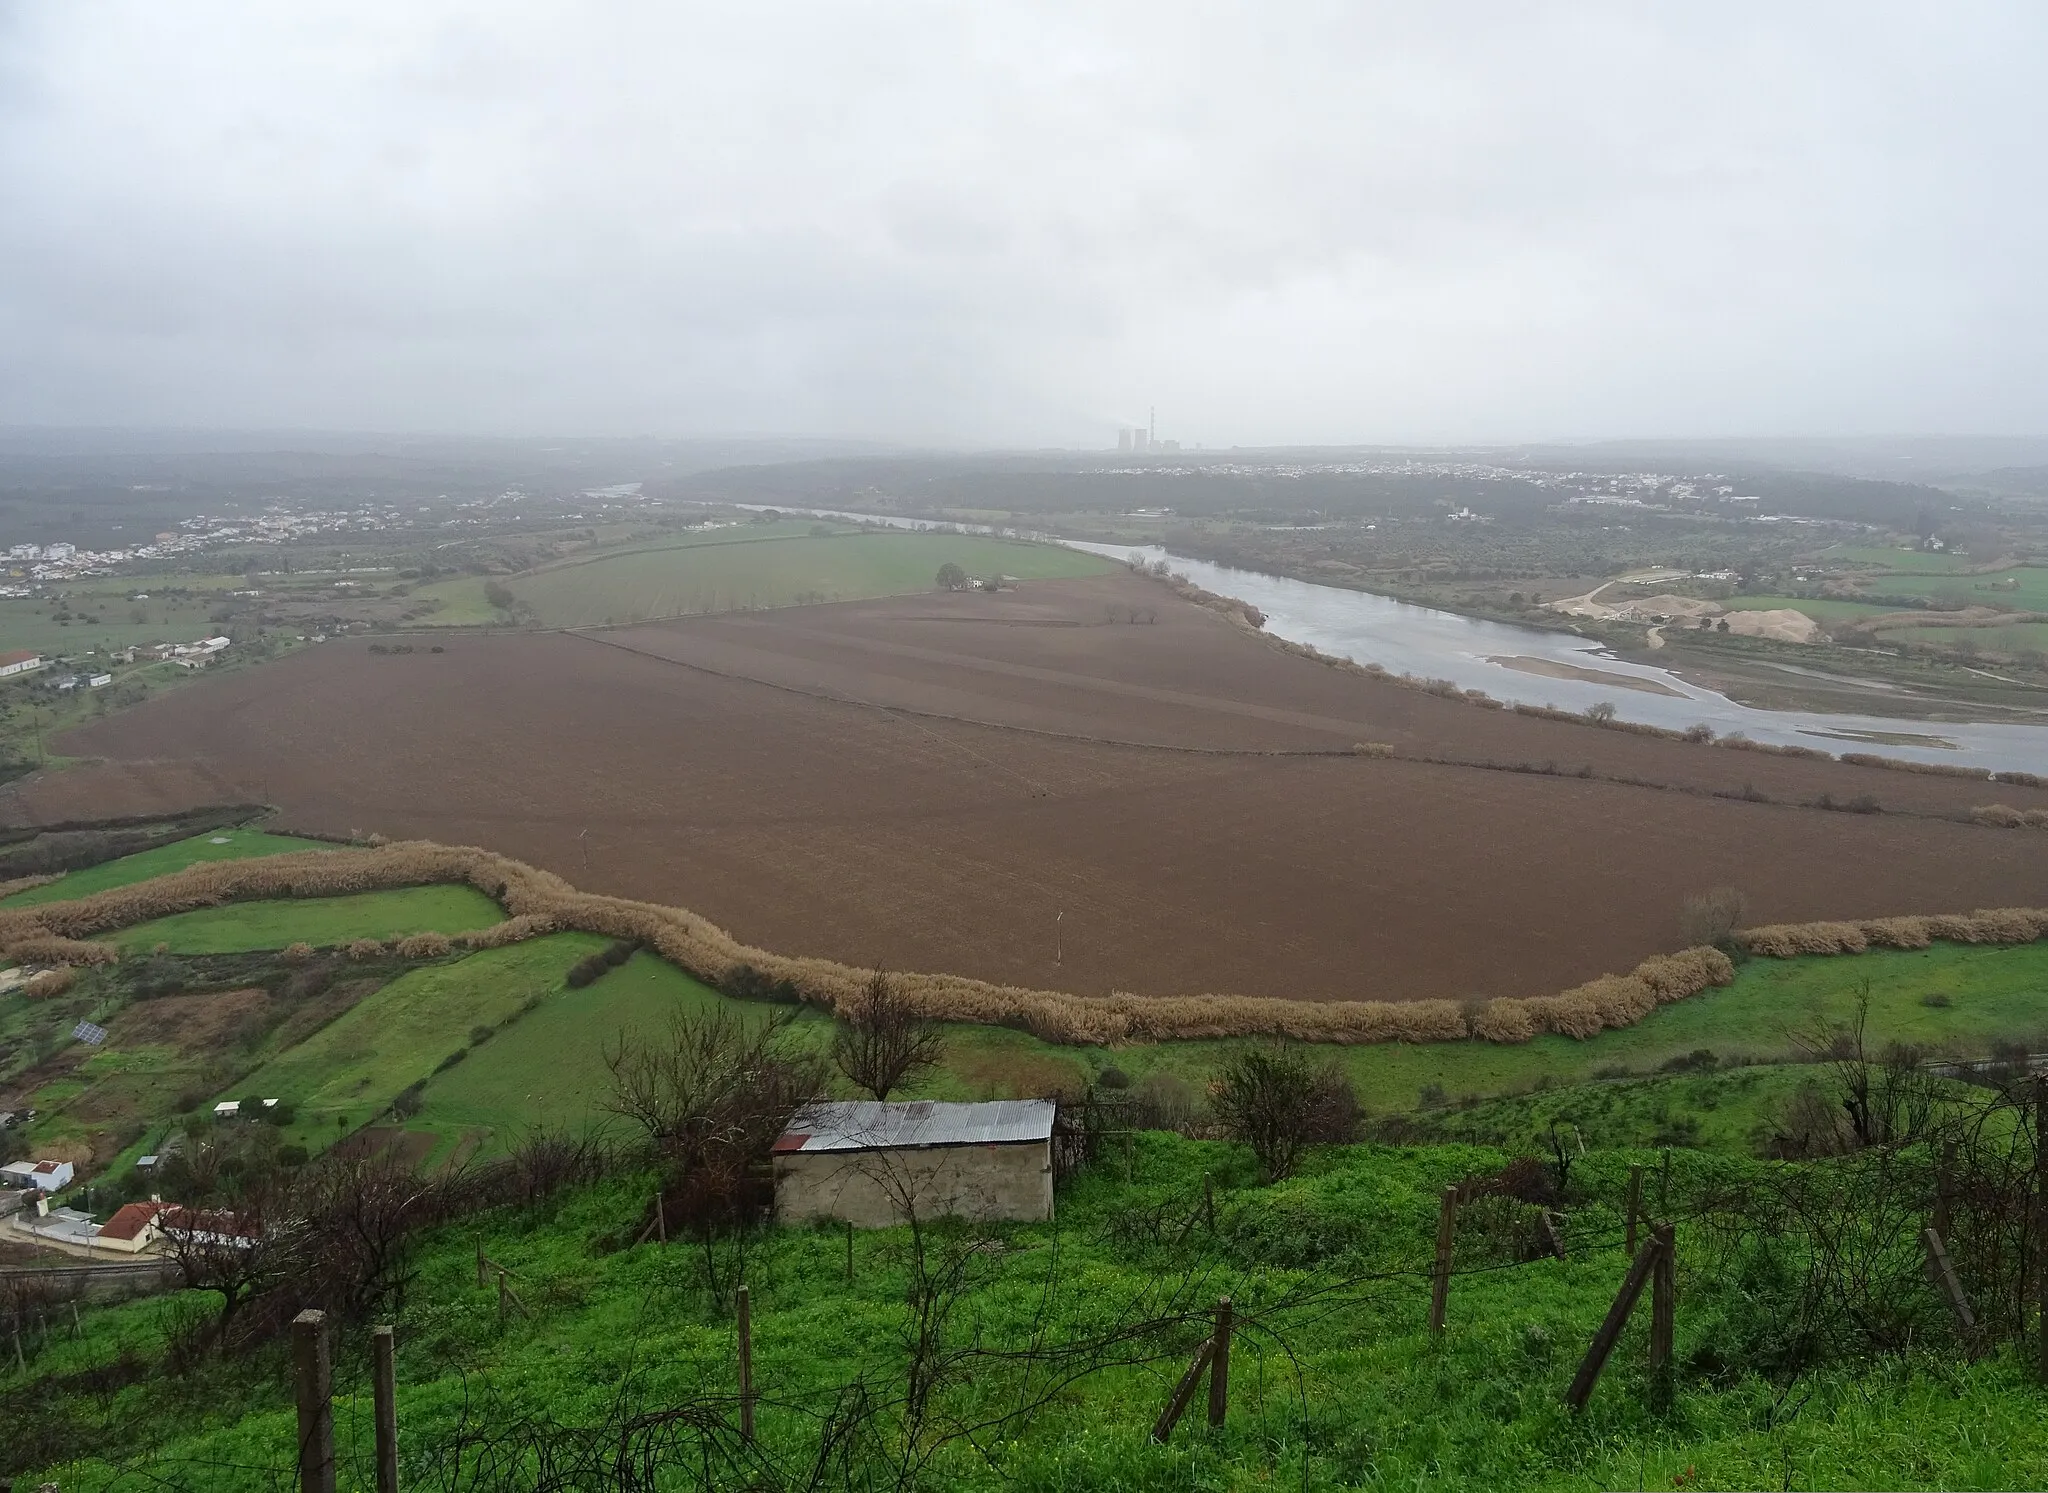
top-left (0, 842), bottom-right (1761, 1044)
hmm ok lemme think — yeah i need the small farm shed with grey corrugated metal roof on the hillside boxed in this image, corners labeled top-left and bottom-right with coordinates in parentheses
top-left (774, 1100), bottom-right (1059, 1229)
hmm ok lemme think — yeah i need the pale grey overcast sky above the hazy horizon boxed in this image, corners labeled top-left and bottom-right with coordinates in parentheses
top-left (0, 0), bottom-right (2048, 446)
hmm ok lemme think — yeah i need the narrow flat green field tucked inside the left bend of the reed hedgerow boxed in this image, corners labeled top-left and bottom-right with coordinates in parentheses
top-left (113, 885), bottom-right (504, 954)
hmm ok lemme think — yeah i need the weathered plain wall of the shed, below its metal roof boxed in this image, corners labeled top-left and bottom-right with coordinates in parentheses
top-left (774, 1141), bottom-right (1053, 1229)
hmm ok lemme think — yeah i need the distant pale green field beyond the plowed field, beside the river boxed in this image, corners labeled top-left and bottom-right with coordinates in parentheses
top-left (506, 535), bottom-right (1112, 627)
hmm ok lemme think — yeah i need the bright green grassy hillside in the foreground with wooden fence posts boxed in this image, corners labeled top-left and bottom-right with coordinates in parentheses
top-left (19, 1135), bottom-right (2048, 1493)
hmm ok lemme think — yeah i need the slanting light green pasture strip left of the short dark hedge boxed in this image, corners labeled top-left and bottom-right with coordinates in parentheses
top-left (221, 934), bottom-right (604, 1149)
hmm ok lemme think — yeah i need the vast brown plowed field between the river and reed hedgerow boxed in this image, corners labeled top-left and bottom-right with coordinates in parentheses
top-left (66, 575), bottom-right (2048, 999)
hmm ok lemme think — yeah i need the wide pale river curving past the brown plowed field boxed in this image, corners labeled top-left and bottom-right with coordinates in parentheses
top-left (716, 504), bottom-right (2048, 774)
